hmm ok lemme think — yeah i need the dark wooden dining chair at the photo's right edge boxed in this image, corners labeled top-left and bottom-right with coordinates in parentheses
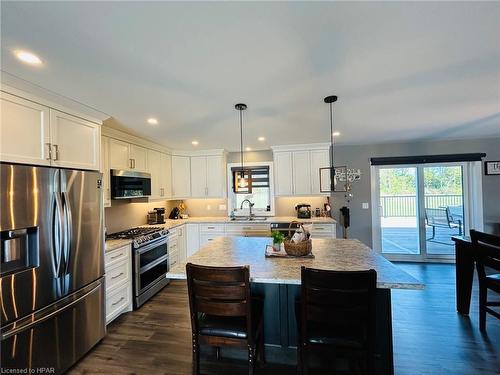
top-left (470, 229), bottom-right (500, 332)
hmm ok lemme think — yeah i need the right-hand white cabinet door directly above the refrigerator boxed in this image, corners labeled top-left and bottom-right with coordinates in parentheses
top-left (50, 109), bottom-right (101, 171)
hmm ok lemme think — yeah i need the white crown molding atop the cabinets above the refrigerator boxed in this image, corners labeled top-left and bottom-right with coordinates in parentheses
top-left (1, 78), bottom-right (110, 124)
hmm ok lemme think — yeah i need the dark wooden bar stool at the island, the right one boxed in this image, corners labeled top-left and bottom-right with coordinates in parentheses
top-left (296, 267), bottom-right (377, 375)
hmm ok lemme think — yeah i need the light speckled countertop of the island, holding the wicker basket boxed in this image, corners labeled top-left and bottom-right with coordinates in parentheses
top-left (167, 237), bottom-right (424, 289)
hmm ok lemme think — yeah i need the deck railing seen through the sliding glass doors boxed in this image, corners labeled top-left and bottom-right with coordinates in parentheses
top-left (380, 194), bottom-right (462, 217)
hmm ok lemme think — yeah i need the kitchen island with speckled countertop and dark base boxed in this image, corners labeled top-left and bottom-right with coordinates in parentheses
top-left (167, 237), bottom-right (424, 374)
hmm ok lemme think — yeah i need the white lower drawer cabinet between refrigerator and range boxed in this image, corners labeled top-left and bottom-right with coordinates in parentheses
top-left (104, 245), bottom-right (132, 324)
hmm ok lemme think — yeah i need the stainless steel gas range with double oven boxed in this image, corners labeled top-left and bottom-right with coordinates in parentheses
top-left (107, 227), bottom-right (170, 309)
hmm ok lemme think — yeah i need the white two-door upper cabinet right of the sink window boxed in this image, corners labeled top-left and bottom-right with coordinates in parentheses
top-left (272, 143), bottom-right (330, 196)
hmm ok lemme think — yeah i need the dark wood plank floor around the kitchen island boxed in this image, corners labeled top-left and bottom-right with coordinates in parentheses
top-left (69, 263), bottom-right (500, 375)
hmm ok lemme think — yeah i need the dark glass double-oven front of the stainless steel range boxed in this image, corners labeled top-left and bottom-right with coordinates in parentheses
top-left (134, 238), bottom-right (168, 296)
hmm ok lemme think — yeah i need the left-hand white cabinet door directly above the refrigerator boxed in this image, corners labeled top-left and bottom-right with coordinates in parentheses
top-left (0, 92), bottom-right (51, 165)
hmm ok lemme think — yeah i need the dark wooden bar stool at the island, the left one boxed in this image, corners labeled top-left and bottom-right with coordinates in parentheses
top-left (186, 263), bottom-right (265, 375)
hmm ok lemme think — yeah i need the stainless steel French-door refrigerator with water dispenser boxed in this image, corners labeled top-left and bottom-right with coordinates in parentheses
top-left (0, 163), bottom-right (106, 373)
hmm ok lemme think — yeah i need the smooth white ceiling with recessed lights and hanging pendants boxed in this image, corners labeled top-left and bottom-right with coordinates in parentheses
top-left (1, 1), bottom-right (500, 150)
